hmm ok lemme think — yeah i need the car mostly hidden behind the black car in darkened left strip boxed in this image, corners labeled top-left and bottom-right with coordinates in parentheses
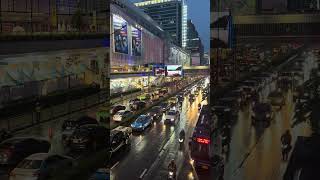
top-left (61, 116), bottom-right (98, 144)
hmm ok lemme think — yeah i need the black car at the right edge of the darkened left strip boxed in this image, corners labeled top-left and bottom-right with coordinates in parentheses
top-left (70, 125), bottom-right (109, 151)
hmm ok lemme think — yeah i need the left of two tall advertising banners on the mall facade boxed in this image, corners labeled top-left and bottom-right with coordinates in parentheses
top-left (113, 15), bottom-right (129, 54)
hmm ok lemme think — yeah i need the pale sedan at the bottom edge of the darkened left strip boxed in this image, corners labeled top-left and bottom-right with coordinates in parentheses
top-left (10, 153), bottom-right (73, 180)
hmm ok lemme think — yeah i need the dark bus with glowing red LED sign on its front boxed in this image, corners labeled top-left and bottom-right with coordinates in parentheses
top-left (190, 105), bottom-right (222, 169)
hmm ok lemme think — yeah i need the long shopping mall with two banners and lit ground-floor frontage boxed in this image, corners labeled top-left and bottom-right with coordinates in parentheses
top-left (110, 0), bottom-right (191, 93)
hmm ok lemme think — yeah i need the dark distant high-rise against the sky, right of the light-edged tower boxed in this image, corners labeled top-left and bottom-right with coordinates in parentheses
top-left (186, 19), bottom-right (204, 66)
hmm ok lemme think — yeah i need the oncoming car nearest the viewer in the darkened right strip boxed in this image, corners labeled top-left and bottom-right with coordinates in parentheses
top-left (251, 103), bottom-right (274, 127)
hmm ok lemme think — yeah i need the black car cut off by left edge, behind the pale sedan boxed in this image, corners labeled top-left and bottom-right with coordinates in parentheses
top-left (0, 137), bottom-right (51, 170)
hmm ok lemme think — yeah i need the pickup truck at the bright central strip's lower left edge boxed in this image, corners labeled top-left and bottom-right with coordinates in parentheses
top-left (110, 126), bottom-right (132, 154)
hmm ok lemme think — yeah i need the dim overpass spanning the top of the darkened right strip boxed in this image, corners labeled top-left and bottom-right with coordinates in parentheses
top-left (233, 14), bottom-right (320, 39)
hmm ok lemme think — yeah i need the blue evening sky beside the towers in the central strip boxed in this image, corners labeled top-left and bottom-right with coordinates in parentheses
top-left (130, 0), bottom-right (210, 52)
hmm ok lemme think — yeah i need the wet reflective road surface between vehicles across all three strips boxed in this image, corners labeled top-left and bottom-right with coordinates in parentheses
top-left (3, 47), bottom-right (314, 180)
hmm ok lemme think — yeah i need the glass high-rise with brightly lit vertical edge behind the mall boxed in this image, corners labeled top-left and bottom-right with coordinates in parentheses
top-left (135, 0), bottom-right (188, 48)
